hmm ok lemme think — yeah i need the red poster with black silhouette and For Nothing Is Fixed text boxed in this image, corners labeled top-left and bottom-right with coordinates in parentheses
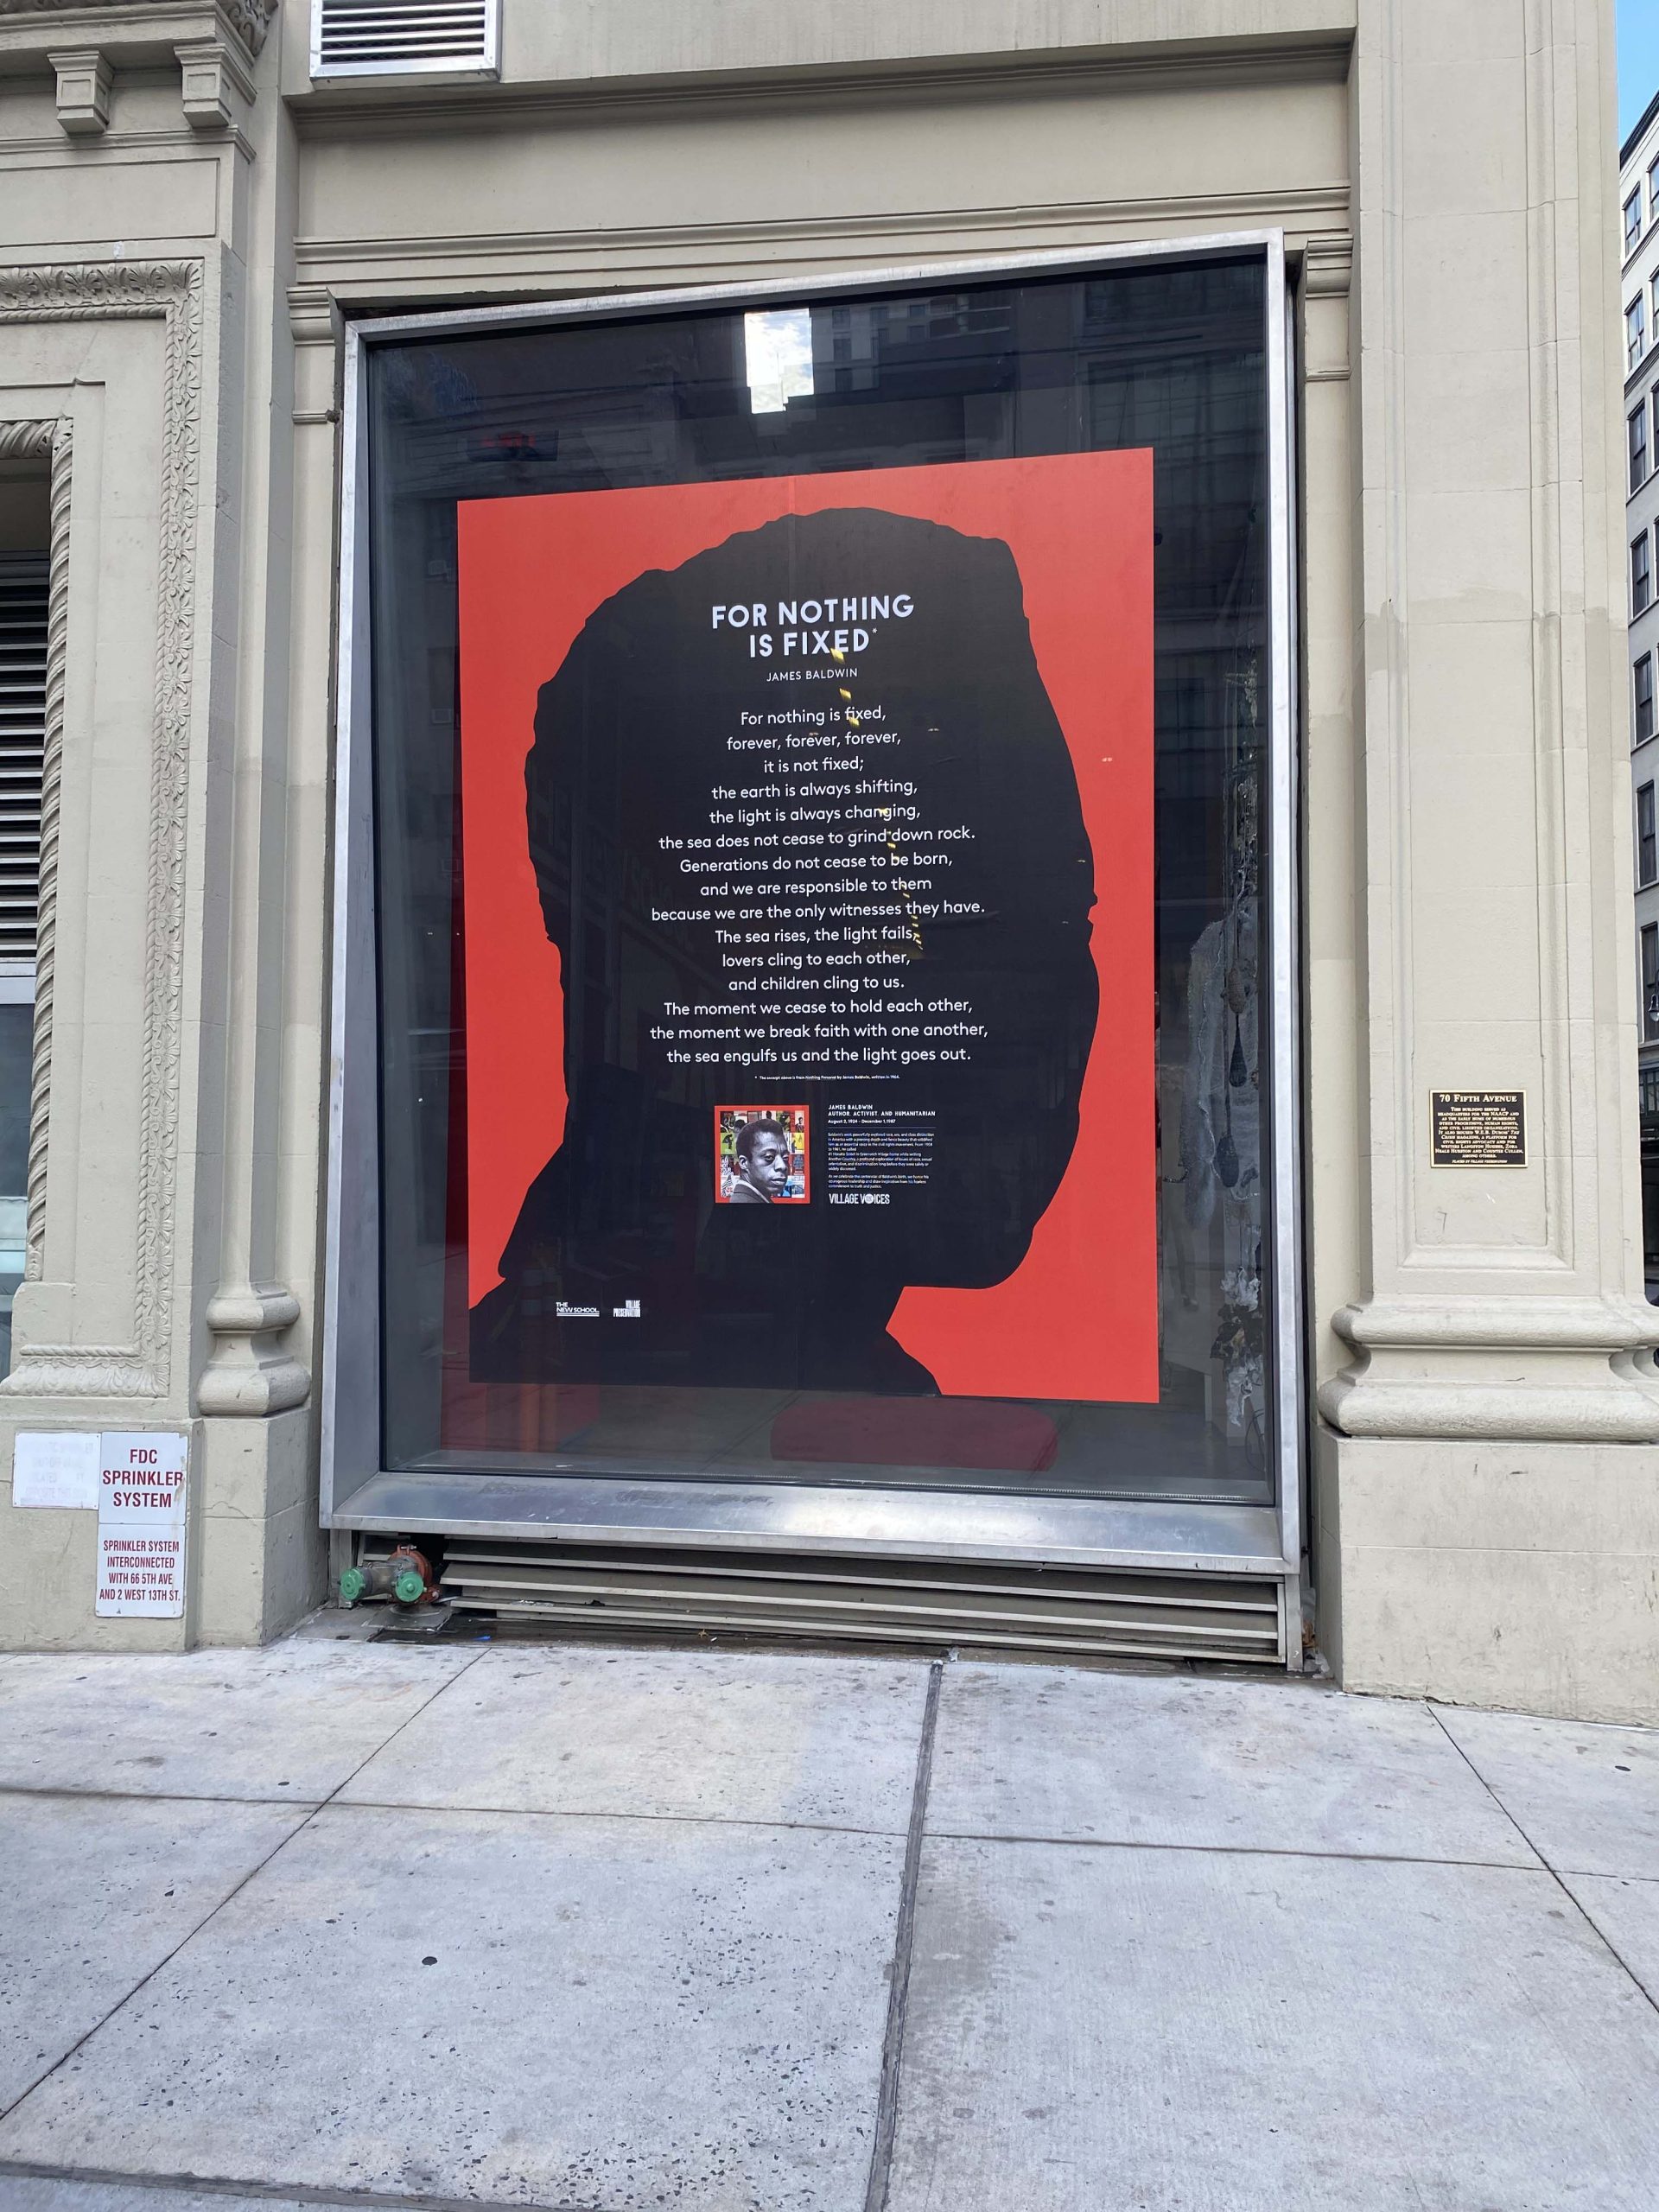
top-left (460, 451), bottom-right (1159, 1402)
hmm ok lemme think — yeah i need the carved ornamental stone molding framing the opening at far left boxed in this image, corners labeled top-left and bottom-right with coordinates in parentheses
top-left (0, 261), bottom-right (201, 1398)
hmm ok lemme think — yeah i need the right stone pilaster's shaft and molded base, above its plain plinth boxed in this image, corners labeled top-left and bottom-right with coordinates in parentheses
top-left (1320, 0), bottom-right (1659, 1442)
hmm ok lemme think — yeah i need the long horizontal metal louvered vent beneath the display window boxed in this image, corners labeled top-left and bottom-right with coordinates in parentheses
top-left (424, 1537), bottom-right (1285, 1666)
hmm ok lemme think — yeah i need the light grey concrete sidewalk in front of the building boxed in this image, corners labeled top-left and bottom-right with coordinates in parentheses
top-left (0, 1615), bottom-right (1659, 2212)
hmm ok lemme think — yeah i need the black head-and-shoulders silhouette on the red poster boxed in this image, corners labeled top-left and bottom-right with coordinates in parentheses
top-left (462, 506), bottom-right (1099, 1394)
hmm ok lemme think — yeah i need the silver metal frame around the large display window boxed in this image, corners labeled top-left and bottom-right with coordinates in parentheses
top-left (321, 230), bottom-right (1307, 1668)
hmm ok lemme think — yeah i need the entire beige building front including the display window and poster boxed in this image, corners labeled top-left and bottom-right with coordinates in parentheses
top-left (0, 0), bottom-right (1659, 1719)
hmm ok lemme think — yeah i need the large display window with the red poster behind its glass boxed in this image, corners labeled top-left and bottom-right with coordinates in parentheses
top-left (327, 241), bottom-right (1294, 1574)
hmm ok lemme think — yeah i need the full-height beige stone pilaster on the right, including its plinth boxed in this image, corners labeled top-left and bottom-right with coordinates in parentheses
top-left (1307, 0), bottom-right (1659, 1717)
